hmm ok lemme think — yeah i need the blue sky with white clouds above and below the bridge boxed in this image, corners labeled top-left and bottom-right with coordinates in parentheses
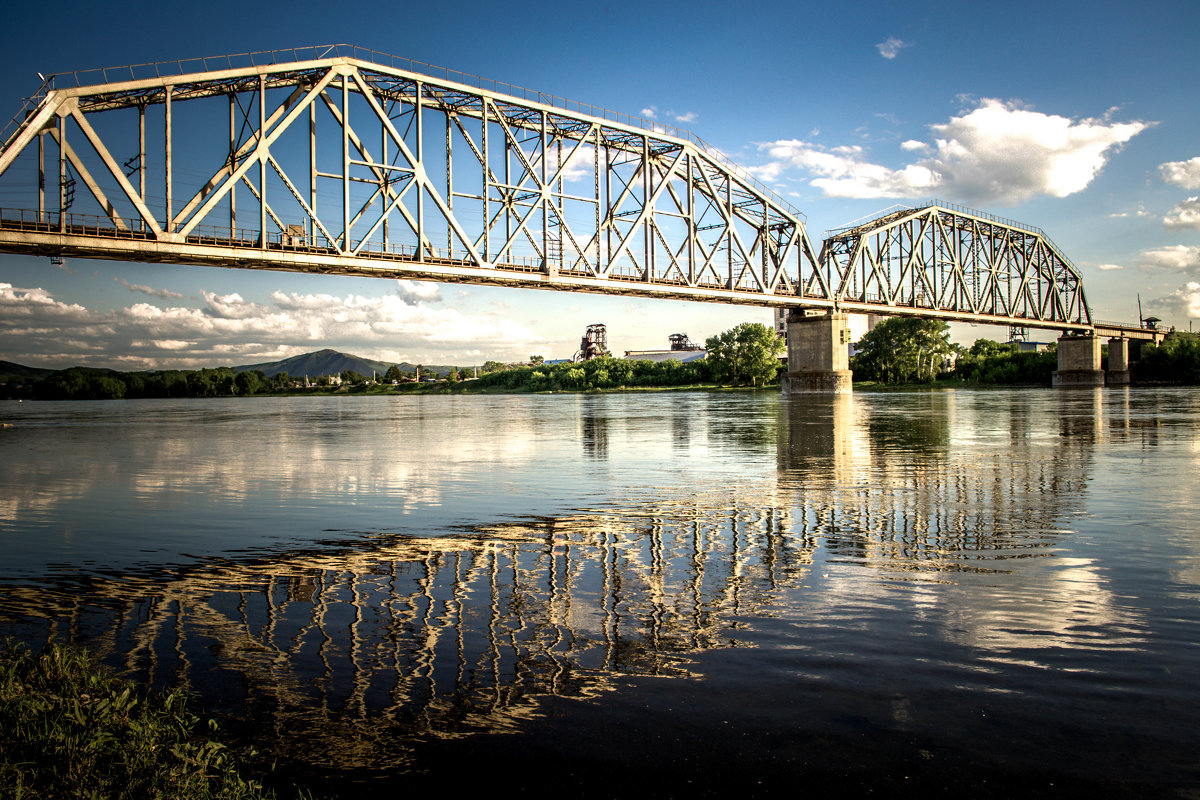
top-left (0, 0), bottom-right (1200, 368)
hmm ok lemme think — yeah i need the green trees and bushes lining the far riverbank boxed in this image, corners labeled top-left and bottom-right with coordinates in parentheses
top-left (0, 326), bottom-right (1200, 399)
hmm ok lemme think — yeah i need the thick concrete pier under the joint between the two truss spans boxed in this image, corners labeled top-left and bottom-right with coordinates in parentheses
top-left (782, 308), bottom-right (852, 395)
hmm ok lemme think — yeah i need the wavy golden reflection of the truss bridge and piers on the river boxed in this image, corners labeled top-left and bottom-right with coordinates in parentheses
top-left (0, 393), bottom-right (1120, 776)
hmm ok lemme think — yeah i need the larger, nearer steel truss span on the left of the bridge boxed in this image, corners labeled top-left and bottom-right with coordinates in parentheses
top-left (0, 50), bottom-right (816, 303)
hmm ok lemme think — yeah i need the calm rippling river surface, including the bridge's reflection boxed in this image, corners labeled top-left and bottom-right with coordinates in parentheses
top-left (0, 389), bottom-right (1200, 798)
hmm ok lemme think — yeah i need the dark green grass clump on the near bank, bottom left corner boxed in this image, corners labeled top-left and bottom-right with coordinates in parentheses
top-left (0, 642), bottom-right (302, 800)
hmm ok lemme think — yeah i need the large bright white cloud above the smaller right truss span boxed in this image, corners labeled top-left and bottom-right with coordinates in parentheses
top-left (755, 98), bottom-right (1150, 205)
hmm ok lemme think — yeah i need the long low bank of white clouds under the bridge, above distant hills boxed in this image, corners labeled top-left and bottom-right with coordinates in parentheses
top-left (0, 282), bottom-right (548, 369)
